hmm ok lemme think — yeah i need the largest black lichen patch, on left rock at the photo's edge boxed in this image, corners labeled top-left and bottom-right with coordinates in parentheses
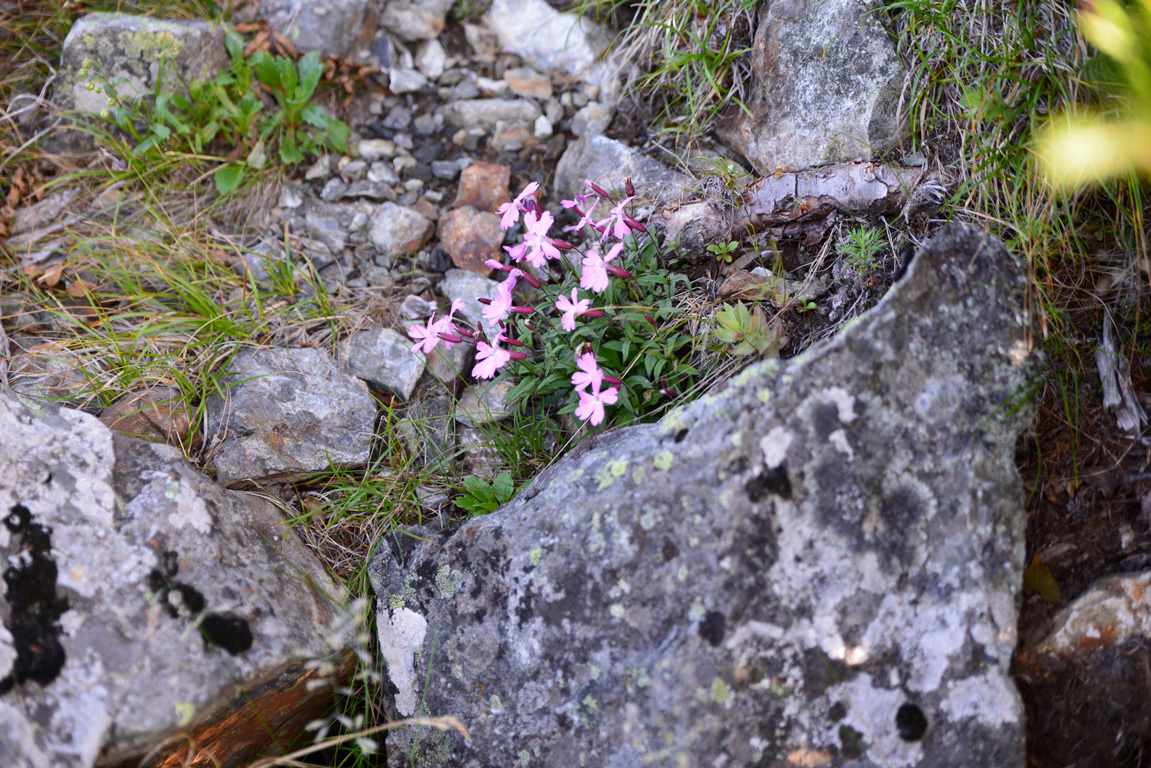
top-left (0, 504), bottom-right (68, 694)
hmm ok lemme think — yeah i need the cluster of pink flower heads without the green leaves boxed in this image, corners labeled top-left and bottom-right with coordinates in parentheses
top-left (407, 180), bottom-right (647, 426)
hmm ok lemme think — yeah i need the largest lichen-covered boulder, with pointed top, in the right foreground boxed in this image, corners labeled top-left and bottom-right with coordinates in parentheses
top-left (372, 225), bottom-right (1034, 767)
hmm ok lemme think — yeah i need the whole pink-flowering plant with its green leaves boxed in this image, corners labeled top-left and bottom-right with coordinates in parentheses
top-left (409, 181), bottom-right (699, 426)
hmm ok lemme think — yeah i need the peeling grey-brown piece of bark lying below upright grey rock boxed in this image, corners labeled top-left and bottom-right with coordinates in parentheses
top-left (661, 162), bottom-right (939, 264)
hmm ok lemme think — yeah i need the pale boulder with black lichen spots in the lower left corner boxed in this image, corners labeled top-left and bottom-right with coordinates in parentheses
top-left (0, 390), bottom-right (346, 768)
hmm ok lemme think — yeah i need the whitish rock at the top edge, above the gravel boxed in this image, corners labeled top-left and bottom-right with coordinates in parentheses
top-left (483, 0), bottom-right (612, 84)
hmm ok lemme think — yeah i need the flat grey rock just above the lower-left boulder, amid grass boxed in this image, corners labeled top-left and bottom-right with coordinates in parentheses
top-left (205, 348), bottom-right (375, 482)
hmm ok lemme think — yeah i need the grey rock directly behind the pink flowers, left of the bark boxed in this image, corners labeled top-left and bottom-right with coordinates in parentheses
top-left (555, 135), bottom-right (689, 210)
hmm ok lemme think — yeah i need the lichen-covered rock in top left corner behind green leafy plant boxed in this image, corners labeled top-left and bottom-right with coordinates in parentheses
top-left (53, 13), bottom-right (228, 149)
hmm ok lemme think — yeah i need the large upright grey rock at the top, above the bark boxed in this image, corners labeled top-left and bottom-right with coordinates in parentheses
top-left (719, 0), bottom-right (904, 175)
